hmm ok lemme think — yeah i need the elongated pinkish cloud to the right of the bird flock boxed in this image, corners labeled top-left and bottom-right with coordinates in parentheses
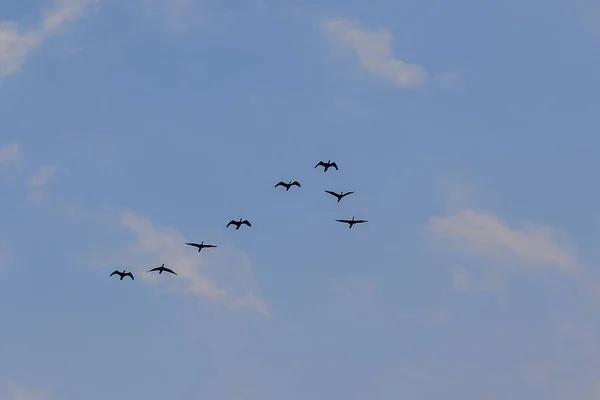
top-left (427, 209), bottom-right (578, 271)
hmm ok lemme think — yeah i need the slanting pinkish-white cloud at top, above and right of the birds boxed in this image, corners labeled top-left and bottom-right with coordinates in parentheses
top-left (321, 18), bottom-right (428, 87)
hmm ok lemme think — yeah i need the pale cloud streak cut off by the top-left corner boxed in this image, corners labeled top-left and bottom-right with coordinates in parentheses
top-left (0, 0), bottom-right (97, 78)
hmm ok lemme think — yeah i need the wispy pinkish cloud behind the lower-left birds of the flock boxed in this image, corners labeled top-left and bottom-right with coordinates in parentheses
top-left (103, 211), bottom-right (269, 315)
